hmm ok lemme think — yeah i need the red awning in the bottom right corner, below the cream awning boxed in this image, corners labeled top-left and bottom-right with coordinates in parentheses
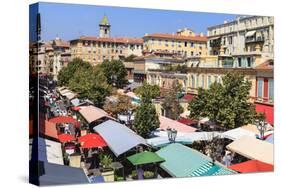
top-left (228, 160), bottom-right (274, 173)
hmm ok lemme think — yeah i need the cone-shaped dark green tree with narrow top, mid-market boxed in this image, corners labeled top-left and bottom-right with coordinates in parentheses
top-left (133, 81), bottom-right (160, 138)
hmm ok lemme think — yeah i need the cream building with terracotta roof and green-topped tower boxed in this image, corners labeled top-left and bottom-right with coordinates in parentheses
top-left (70, 16), bottom-right (143, 66)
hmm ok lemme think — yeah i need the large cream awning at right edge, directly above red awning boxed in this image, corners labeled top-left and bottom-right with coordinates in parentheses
top-left (226, 136), bottom-right (273, 164)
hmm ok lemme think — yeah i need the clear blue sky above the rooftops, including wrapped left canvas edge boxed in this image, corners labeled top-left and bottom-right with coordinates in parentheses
top-left (29, 3), bottom-right (247, 41)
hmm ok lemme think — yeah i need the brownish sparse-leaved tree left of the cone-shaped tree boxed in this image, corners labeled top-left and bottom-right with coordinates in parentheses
top-left (103, 95), bottom-right (134, 117)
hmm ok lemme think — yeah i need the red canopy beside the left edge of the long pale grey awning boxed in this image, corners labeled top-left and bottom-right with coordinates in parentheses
top-left (78, 133), bottom-right (107, 148)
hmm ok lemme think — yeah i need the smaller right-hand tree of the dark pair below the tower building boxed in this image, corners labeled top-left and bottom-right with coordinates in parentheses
top-left (96, 60), bottom-right (127, 88)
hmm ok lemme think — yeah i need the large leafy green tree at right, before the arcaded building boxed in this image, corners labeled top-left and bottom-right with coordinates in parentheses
top-left (189, 73), bottom-right (257, 128)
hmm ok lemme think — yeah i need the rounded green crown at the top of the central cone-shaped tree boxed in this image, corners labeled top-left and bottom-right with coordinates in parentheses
top-left (135, 82), bottom-right (160, 102)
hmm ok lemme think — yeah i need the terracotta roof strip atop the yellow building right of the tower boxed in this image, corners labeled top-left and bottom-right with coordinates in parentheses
top-left (144, 33), bottom-right (208, 42)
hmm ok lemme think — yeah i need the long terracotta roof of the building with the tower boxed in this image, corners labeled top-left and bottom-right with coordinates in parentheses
top-left (75, 36), bottom-right (143, 44)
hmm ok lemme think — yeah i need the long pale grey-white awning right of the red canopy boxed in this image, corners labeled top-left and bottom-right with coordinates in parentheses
top-left (94, 120), bottom-right (146, 156)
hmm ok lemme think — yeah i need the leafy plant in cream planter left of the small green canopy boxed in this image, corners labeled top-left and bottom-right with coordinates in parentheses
top-left (100, 155), bottom-right (114, 182)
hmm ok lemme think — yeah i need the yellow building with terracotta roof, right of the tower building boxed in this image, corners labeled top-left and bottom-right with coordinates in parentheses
top-left (143, 28), bottom-right (208, 57)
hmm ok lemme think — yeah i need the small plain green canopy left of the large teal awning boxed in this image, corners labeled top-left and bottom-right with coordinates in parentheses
top-left (127, 151), bottom-right (165, 165)
